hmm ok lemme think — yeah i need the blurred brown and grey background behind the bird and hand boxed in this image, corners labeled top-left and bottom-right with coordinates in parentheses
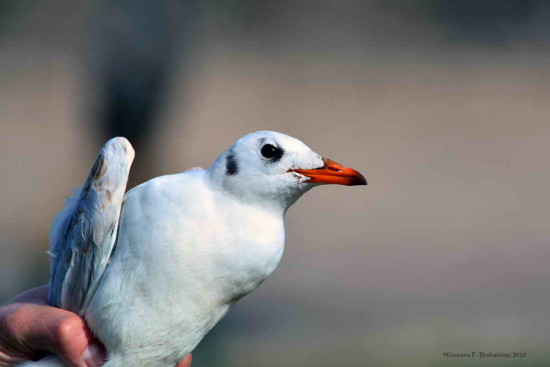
top-left (0, 0), bottom-right (550, 367)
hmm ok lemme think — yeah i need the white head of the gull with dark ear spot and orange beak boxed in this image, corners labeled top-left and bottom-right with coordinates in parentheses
top-left (208, 131), bottom-right (367, 210)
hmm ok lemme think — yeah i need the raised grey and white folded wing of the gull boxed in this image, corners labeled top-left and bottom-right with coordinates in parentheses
top-left (48, 138), bottom-right (134, 316)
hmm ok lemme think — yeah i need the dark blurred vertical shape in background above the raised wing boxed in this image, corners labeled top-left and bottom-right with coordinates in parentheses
top-left (94, 0), bottom-right (200, 151)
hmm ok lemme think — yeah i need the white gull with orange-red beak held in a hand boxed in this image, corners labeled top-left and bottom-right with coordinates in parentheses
top-left (22, 131), bottom-right (366, 367)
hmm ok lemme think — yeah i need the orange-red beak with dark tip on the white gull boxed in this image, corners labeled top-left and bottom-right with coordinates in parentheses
top-left (292, 158), bottom-right (367, 186)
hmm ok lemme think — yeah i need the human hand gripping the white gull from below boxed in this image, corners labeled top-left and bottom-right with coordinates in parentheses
top-left (0, 286), bottom-right (192, 367)
